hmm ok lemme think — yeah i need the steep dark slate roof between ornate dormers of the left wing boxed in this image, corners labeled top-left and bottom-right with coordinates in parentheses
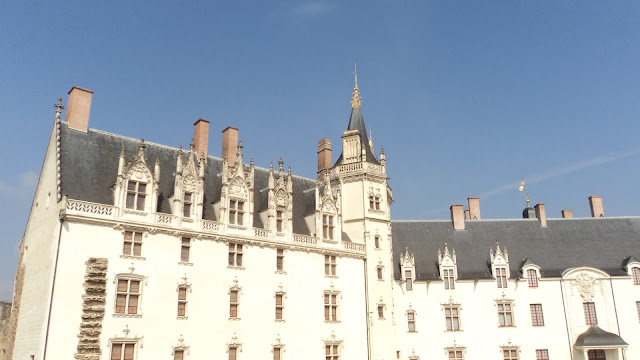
top-left (60, 122), bottom-right (316, 234)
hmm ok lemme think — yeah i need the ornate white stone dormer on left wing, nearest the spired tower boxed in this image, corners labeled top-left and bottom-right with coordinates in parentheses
top-left (316, 172), bottom-right (342, 242)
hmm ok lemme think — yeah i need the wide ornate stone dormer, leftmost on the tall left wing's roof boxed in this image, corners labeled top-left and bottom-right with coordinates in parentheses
top-left (114, 139), bottom-right (160, 215)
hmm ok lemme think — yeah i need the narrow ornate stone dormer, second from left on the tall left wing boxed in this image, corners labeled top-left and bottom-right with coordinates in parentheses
top-left (170, 141), bottom-right (204, 219)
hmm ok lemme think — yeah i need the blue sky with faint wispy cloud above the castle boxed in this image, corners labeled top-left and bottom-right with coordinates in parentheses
top-left (0, 0), bottom-right (640, 300)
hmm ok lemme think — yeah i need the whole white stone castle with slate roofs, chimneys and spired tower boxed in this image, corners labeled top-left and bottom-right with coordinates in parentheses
top-left (0, 78), bottom-right (640, 360)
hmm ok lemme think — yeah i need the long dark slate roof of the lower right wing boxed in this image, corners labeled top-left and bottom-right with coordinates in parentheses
top-left (392, 217), bottom-right (640, 281)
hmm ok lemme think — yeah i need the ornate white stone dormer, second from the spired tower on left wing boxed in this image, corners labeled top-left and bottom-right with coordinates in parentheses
top-left (266, 158), bottom-right (293, 233)
